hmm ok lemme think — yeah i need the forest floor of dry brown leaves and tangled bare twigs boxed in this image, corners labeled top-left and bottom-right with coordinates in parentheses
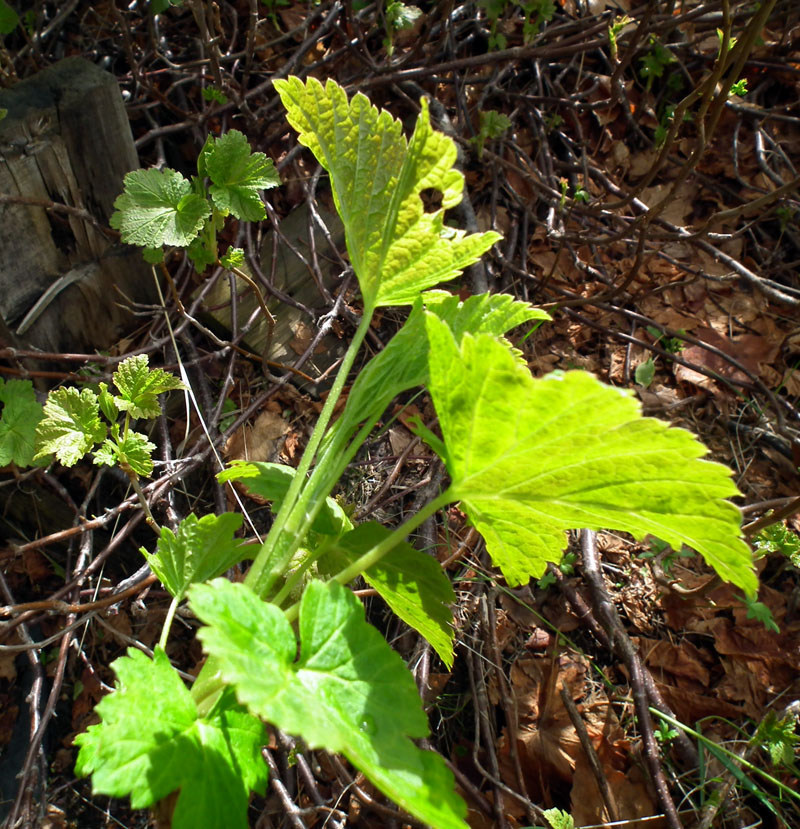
top-left (0, 0), bottom-right (800, 829)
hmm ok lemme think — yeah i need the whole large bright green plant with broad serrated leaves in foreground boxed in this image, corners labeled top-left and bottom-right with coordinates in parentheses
top-left (70, 78), bottom-right (757, 829)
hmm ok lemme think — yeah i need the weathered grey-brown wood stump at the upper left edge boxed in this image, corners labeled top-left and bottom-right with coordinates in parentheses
top-left (0, 58), bottom-right (155, 352)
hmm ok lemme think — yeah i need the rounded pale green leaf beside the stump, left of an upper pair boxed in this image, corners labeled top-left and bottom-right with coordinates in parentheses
top-left (109, 168), bottom-right (211, 248)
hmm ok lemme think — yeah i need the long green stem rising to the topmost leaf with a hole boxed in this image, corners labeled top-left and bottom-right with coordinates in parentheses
top-left (245, 309), bottom-right (372, 599)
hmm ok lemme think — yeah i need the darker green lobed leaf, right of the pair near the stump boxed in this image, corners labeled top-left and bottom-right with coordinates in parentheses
top-left (203, 130), bottom-right (281, 222)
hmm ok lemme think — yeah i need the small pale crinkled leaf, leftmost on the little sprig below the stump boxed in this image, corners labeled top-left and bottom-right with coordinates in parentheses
top-left (34, 387), bottom-right (107, 466)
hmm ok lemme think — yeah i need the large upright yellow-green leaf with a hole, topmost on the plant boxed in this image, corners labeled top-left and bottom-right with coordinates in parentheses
top-left (275, 77), bottom-right (500, 312)
